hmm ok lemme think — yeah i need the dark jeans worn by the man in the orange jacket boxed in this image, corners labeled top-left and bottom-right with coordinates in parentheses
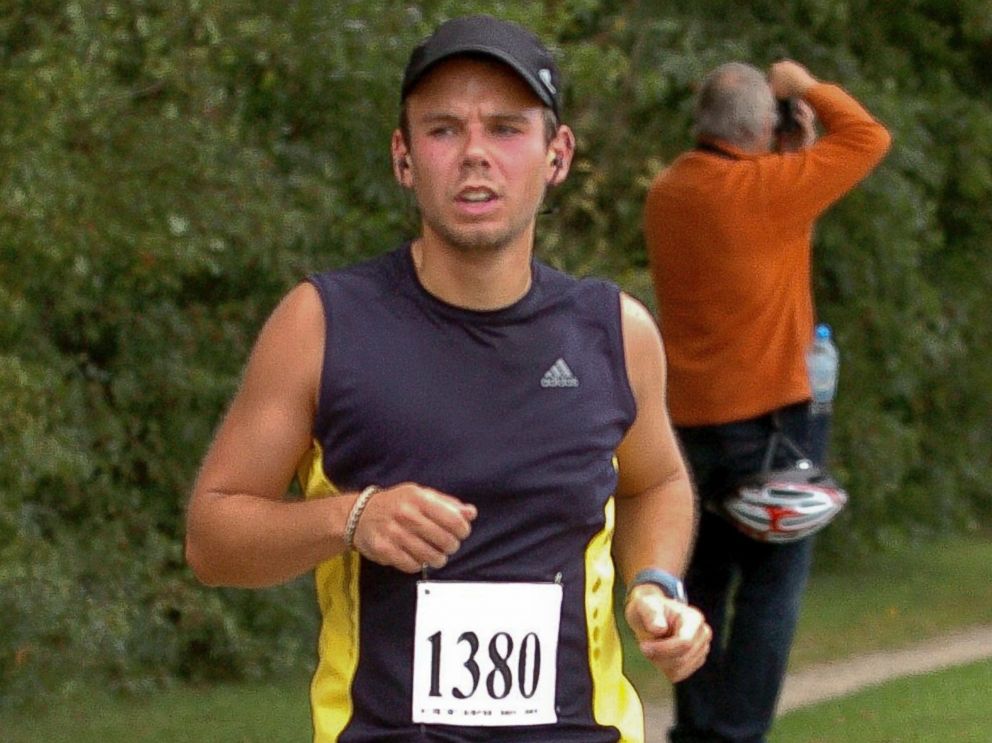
top-left (669, 405), bottom-right (830, 743)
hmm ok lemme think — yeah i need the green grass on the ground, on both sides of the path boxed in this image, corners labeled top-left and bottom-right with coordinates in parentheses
top-left (0, 538), bottom-right (992, 743)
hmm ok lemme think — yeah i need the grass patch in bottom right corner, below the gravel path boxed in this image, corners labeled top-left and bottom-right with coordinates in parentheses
top-left (771, 661), bottom-right (992, 743)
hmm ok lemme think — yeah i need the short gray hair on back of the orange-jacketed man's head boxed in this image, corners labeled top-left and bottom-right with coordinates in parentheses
top-left (693, 62), bottom-right (775, 147)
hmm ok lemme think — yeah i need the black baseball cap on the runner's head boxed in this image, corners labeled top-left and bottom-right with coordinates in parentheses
top-left (400, 14), bottom-right (561, 117)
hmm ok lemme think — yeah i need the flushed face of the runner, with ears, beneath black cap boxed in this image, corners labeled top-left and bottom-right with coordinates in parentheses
top-left (393, 57), bottom-right (560, 251)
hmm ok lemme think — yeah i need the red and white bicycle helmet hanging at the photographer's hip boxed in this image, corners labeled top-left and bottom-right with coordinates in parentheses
top-left (723, 459), bottom-right (847, 543)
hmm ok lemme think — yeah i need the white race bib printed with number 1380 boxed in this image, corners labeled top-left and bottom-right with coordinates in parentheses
top-left (413, 581), bottom-right (562, 726)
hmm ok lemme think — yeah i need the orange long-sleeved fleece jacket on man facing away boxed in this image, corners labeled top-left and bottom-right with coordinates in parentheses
top-left (644, 83), bottom-right (890, 426)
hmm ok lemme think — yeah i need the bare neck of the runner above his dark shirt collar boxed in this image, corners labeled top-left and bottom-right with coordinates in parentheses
top-left (410, 237), bottom-right (533, 311)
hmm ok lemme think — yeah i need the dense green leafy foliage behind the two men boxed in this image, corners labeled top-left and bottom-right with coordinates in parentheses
top-left (0, 0), bottom-right (992, 705)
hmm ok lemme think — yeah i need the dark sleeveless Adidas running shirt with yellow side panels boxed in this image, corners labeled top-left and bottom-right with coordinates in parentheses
top-left (300, 244), bottom-right (641, 743)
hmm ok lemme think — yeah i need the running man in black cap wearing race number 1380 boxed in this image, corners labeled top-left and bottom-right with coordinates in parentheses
top-left (186, 16), bottom-right (710, 743)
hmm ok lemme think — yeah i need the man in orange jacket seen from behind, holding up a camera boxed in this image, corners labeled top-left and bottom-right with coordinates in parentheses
top-left (644, 61), bottom-right (889, 743)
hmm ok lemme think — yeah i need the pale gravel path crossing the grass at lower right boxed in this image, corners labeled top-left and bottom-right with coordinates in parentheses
top-left (644, 626), bottom-right (992, 743)
